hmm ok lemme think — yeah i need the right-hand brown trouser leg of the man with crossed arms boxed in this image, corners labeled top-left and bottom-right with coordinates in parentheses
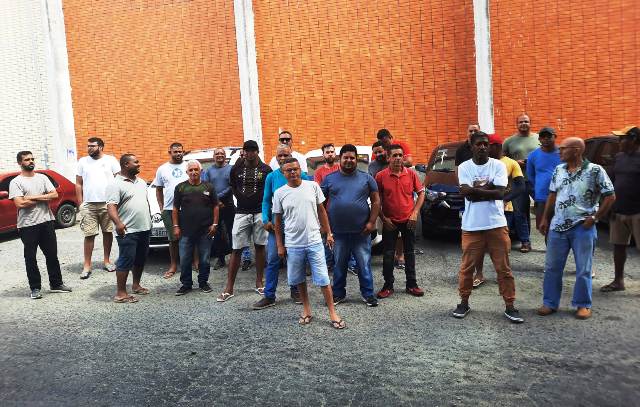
top-left (485, 228), bottom-right (516, 308)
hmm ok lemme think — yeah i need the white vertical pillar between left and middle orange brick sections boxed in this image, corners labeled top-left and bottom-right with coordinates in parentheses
top-left (233, 0), bottom-right (264, 159)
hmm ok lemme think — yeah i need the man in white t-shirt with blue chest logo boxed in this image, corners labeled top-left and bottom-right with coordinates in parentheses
top-left (153, 142), bottom-right (189, 278)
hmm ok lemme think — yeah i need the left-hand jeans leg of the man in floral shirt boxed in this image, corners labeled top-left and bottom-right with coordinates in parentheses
top-left (542, 230), bottom-right (571, 310)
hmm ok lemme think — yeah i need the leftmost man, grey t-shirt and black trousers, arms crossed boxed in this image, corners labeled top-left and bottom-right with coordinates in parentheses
top-left (9, 151), bottom-right (71, 300)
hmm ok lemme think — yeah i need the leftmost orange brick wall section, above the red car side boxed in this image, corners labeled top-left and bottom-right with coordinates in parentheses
top-left (63, 0), bottom-right (243, 179)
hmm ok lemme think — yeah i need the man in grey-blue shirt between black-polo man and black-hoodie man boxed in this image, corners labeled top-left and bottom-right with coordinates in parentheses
top-left (202, 147), bottom-right (236, 270)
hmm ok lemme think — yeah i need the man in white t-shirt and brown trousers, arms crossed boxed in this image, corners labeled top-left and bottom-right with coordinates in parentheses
top-left (453, 131), bottom-right (524, 323)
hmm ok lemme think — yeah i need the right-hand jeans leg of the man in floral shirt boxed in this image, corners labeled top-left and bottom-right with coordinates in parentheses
top-left (570, 225), bottom-right (598, 308)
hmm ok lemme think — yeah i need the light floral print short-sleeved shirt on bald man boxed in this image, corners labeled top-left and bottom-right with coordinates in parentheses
top-left (549, 160), bottom-right (614, 232)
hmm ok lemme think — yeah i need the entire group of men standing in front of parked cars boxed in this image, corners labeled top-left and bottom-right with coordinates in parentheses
top-left (10, 120), bottom-right (640, 329)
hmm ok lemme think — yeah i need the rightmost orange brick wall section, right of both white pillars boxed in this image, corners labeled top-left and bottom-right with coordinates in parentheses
top-left (490, 0), bottom-right (640, 137)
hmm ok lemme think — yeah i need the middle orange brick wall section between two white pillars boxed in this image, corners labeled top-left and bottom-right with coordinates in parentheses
top-left (253, 0), bottom-right (477, 162)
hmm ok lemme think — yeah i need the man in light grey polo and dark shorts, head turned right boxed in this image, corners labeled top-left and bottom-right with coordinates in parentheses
top-left (107, 154), bottom-right (151, 303)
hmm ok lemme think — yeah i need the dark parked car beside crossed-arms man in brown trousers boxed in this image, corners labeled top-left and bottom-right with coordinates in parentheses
top-left (420, 141), bottom-right (464, 238)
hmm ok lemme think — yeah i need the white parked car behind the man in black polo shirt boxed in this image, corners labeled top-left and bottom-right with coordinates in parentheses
top-left (147, 147), bottom-right (242, 248)
